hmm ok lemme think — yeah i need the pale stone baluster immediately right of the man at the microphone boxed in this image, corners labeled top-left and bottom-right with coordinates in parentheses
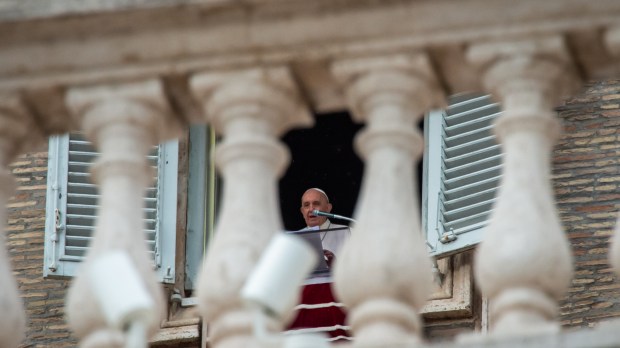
top-left (332, 54), bottom-right (440, 347)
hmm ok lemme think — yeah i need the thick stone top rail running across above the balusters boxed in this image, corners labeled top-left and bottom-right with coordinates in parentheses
top-left (0, 0), bottom-right (620, 111)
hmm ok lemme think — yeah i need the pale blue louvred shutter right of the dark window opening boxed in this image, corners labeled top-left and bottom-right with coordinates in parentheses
top-left (423, 95), bottom-right (502, 257)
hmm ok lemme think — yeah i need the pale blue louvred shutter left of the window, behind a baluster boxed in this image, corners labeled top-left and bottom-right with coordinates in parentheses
top-left (44, 133), bottom-right (177, 282)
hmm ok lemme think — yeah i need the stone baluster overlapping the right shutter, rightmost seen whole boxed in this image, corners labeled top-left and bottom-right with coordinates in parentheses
top-left (467, 37), bottom-right (576, 336)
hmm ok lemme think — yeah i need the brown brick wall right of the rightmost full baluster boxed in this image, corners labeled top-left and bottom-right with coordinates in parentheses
top-left (550, 80), bottom-right (620, 327)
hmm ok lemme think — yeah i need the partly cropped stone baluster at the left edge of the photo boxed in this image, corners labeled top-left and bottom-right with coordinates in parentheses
top-left (0, 94), bottom-right (43, 348)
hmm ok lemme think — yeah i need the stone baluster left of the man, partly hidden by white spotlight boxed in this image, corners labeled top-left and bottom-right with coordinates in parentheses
top-left (191, 68), bottom-right (312, 348)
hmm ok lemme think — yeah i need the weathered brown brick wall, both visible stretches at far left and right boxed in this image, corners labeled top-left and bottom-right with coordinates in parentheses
top-left (7, 80), bottom-right (620, 347)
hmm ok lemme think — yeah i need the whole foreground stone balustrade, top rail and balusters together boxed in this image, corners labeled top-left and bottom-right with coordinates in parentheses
top-left (0, 0), bottom-right (620, 348)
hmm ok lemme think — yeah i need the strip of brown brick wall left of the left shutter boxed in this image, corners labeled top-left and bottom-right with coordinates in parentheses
top-left (6, 152), bottom-right (76, 347)
